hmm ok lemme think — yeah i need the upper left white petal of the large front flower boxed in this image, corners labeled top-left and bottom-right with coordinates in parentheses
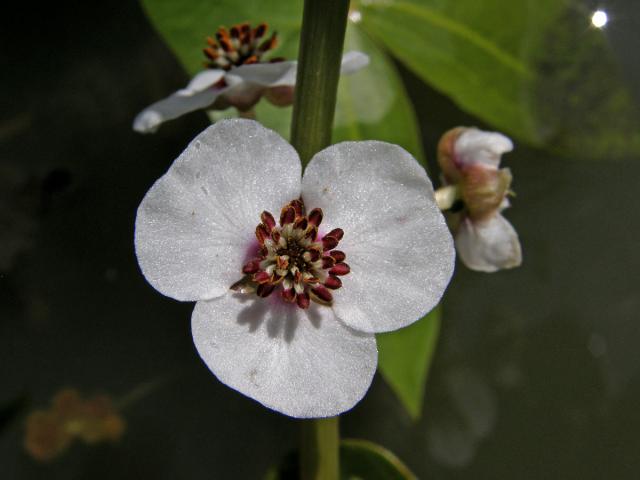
top-left (135, 119), bottom-right (301, 300)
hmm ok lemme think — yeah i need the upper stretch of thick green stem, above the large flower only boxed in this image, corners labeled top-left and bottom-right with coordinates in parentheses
top-left (291, 0), bottom-right (349, 167)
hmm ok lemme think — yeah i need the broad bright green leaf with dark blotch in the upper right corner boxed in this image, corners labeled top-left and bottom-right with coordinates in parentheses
top-left (359, 0), bottom-right (640, 157)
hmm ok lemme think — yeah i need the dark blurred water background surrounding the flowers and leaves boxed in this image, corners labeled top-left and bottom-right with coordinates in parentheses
top-left (0, 0), bottom-right (640, 479)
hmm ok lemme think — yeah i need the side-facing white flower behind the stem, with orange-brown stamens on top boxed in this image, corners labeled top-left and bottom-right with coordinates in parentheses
top-left (133, 23), bottom-right (369, 133)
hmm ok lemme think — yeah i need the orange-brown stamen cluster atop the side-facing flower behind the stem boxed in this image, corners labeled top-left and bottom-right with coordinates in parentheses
top-left (203, 23), bottom-right (282, 70)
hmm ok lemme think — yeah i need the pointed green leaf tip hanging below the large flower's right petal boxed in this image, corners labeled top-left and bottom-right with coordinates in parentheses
top-left (376, 308), bottom-right (440, 420)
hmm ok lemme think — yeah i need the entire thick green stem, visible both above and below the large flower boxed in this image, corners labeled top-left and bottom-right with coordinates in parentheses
top-left (291, 0), bottom-right (349, 480)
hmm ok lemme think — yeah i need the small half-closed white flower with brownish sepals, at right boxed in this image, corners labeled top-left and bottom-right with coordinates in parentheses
top-left (438, 127), bottom-right (522, 272)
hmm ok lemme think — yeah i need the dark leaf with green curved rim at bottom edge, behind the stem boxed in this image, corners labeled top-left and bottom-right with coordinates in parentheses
top-left (264, 439), bottom-right (417, 480)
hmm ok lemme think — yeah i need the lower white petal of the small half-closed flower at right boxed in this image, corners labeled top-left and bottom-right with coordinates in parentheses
top-left (456, 213), bottom-right (522, 272)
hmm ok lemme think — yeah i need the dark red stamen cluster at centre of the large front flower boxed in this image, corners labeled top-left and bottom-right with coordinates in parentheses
top-left (231, 200), bottom-right (350, 308)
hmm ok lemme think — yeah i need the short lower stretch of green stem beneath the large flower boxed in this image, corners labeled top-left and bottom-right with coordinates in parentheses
top-left (300, 417), bottom-right (340, 480)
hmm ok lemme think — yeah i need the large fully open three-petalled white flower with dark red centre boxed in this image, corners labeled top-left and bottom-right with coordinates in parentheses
top-left (135, 119), bottom-right (455, 417)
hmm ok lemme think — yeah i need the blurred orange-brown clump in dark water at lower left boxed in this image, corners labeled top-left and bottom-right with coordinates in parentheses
top-left (24, 389), bottom-right (125, 461)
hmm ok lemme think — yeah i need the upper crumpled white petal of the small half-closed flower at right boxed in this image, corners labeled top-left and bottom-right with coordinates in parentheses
top-left (454, 128), bottom-right (513, 168)
